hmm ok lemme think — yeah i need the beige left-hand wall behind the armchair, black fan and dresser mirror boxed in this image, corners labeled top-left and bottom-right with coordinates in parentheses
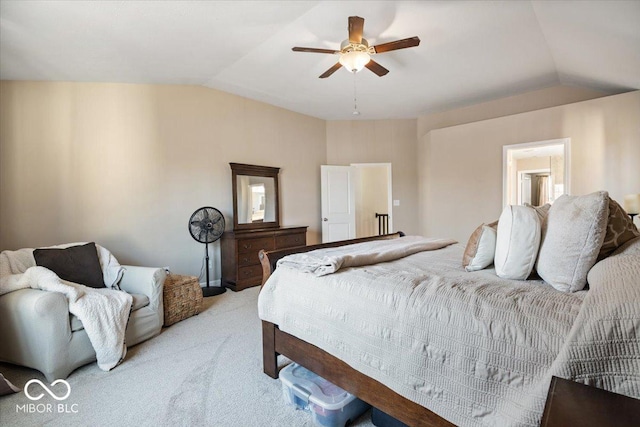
top-left (0, 81), bottom-right (326, 278)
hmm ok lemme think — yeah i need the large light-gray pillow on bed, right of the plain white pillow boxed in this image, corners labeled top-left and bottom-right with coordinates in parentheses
top-left (536, 191), bottom-right (609, 292)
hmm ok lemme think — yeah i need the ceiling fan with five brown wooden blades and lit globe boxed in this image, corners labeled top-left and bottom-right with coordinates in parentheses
top-left (292, 16), bottom-right (420, 79)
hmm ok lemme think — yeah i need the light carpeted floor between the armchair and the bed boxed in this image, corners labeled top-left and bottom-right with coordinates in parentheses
top-left (0, 288), bottom-right (373, 427)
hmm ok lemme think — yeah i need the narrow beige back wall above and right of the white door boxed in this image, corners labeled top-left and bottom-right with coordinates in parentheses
top-left (327, 119), bottom-right (419, 234)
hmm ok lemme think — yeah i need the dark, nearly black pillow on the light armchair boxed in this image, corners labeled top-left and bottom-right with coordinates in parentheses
top-left (33, 242), bottom-right (105, 288)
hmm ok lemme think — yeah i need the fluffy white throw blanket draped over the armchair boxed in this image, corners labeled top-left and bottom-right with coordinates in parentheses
top-left (0, 245), bottom-right (133, 371)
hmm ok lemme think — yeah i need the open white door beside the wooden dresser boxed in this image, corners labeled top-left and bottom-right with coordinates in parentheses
top-left (320, 165), bottom-right (356, 243)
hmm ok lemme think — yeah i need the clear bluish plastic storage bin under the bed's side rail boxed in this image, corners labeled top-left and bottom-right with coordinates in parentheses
top-left (280, 363), bottom-right (370, 427)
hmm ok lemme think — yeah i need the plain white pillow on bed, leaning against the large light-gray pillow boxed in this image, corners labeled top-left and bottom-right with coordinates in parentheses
top-left (494, 206), bottom-right (541, 280)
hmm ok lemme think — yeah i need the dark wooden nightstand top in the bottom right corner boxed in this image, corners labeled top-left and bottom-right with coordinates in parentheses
top-left (540, 377), bottom-right (640, 427)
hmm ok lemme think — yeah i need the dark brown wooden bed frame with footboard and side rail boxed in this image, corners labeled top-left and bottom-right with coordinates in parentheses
top-left (259, 232), bottom-right (454, 427)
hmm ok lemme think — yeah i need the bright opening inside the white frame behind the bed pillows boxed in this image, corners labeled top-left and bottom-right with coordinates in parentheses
top-left (502, 138), bottom-right (570, 206)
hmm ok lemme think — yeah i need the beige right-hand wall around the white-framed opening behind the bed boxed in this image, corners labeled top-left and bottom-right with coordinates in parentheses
top-left (419, 91), bottom-right (640, 242)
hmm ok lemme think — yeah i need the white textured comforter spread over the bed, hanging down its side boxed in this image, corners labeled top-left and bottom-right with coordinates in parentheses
top-left (258, 239), bottom-right (640, 426)
